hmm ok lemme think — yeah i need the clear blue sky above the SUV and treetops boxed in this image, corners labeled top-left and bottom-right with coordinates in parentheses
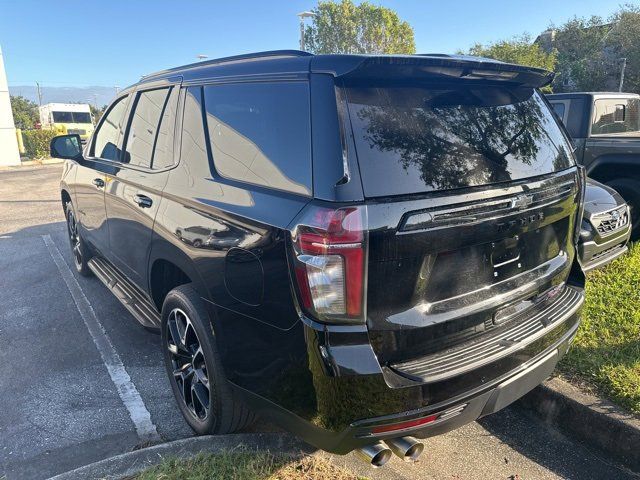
top-left (0, 0), bottom-right (624, 87)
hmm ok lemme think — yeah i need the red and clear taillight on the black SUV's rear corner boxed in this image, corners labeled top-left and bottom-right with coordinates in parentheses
top-left (291, 206), bottom-right (366, 321)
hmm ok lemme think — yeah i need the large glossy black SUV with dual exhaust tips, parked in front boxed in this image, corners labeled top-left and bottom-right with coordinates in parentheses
top-left (51, 51), bottom-right (584, 465)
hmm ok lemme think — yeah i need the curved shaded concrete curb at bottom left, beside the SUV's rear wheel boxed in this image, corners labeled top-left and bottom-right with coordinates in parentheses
top-left (49, 433), bottom-right (309, 480)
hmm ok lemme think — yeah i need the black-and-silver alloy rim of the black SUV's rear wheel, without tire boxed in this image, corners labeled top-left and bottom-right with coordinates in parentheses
top-left (166, 308), bottom-right (211, 422)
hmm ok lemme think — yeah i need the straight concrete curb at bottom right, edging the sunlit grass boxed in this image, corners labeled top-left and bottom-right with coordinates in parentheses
top-left (521, 378), bottom-right (640, 472)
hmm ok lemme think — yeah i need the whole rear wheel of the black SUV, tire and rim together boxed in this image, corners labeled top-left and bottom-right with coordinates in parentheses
top-left (161, 284), bottom-right (255, 435)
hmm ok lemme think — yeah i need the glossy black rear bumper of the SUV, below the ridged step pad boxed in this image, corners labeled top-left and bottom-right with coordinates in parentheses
top-left (236, 290), bottom-right (583, 454)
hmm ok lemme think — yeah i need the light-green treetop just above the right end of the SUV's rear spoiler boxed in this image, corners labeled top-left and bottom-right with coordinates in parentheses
top-left (468, 33), bottom-right (557, 92)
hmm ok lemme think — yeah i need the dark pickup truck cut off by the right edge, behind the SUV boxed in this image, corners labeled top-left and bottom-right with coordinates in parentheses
top-left (547, 92), bottom-right (640, 240)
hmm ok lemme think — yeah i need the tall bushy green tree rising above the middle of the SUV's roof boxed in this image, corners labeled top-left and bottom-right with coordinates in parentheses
top-left (304, 0), bottom-right (416, 54)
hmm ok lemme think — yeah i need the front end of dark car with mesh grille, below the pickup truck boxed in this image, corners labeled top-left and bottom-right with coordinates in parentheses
top-left (578, 178), bottom-right (631, 272)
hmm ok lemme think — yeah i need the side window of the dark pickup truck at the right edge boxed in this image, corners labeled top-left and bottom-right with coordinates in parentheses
top-left (591, 98), bottom-right (640, 136)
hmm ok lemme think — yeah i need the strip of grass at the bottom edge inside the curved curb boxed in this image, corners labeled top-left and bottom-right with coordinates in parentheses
top-left (133, 450), bottom-right (366, 480)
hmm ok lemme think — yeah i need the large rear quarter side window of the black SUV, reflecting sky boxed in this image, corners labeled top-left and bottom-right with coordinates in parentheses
top-left (204, 82), bottom-right (311, 195)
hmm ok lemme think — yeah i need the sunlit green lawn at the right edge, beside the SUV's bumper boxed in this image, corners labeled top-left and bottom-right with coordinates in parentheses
top-left (560, 242), bottom-right (640, 413)
